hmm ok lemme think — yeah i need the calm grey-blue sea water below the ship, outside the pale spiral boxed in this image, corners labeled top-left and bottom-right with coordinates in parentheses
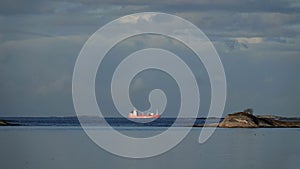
top-left (0, 117), bottom-right (300, 169)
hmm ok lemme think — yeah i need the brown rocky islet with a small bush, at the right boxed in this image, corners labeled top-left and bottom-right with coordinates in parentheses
top-left (218, 112), bottom-right (300, 128)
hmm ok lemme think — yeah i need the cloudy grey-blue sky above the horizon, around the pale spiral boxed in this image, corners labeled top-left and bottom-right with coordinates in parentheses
top-left (0, 0), bottom-right (300, 116)
